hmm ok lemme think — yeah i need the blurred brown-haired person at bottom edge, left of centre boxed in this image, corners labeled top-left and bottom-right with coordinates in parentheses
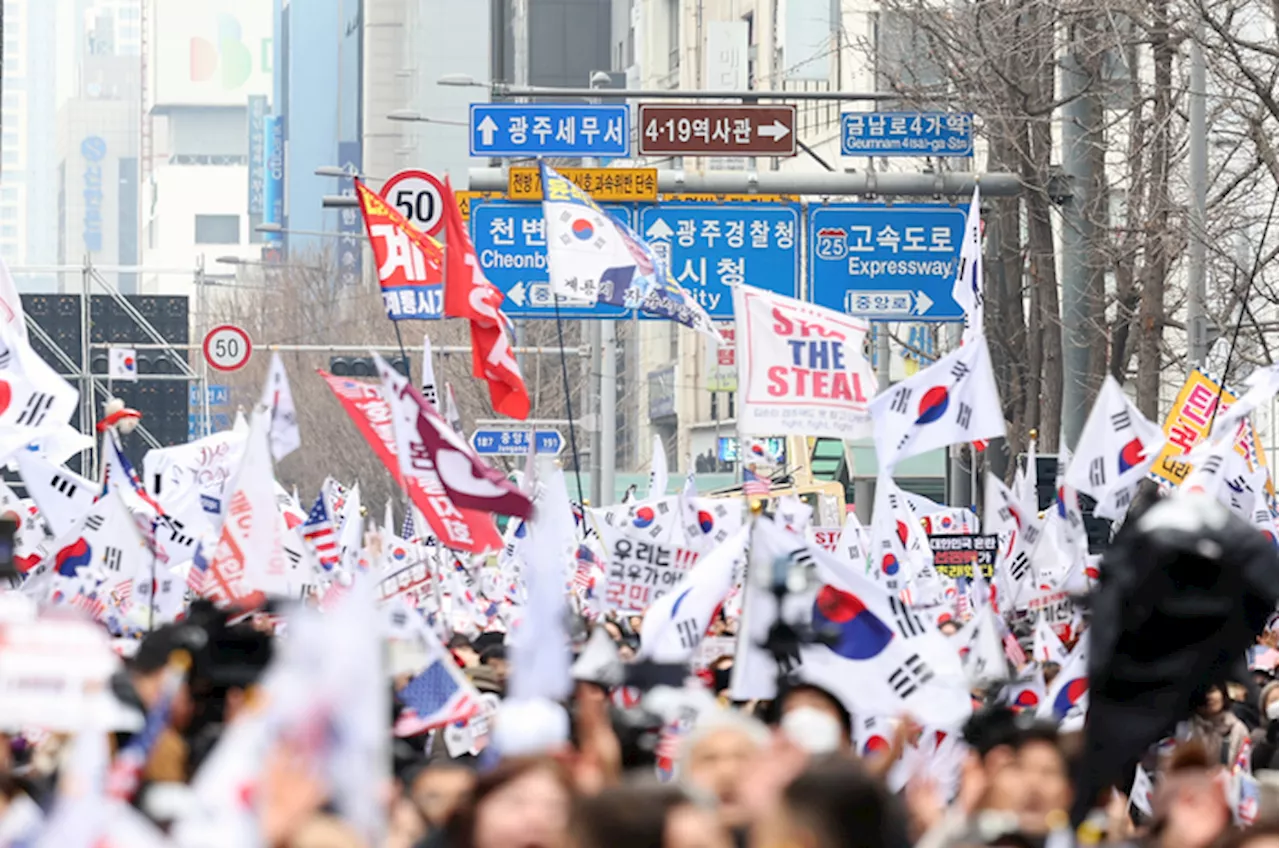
top-left (443, 757), bottom-right (575, 848)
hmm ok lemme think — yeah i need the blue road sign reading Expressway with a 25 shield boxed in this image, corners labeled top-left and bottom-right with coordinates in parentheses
top-left (809, 204), bottom-right (965, 322)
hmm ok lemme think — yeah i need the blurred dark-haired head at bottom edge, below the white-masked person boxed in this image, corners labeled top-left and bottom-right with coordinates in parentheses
top-left (755, 758), bottom-right (911, 848)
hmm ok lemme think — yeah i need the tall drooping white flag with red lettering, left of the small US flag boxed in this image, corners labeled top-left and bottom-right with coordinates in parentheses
top-left (206, 412), bottom-right (289, 603)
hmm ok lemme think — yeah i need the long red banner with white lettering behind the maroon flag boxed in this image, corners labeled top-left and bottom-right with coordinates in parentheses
top-left (320, 370), bottom-right (502, 553)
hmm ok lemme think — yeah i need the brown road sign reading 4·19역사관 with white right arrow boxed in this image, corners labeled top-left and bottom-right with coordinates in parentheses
top-left (639, 104), bottom-right (796, 156)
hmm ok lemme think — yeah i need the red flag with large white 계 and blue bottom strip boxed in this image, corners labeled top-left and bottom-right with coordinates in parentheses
top-left (356, 179), bottom-right (444, 322)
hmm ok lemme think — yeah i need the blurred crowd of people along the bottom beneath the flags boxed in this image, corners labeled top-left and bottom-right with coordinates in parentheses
top-left (0, 581), bottom-right (1280, 848)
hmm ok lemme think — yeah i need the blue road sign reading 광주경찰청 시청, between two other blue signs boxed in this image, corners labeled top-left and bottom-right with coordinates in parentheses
top-left (640, 204), bottom-right (800, 319)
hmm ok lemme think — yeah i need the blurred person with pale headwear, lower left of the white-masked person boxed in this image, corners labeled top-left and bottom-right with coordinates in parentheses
top-left (676, 708), bottom-right (769, 829)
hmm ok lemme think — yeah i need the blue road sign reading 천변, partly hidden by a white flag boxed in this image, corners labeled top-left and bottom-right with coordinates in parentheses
top-left (471, 200), bottom-right (631, 319)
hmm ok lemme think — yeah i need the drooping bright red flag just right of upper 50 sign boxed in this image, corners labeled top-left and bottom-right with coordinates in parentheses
top-left (440, 177), bottom-right (529, 420)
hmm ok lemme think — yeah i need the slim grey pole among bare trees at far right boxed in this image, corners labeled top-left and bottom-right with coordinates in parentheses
top-left (1187, 24), bottom-right (1208, 368)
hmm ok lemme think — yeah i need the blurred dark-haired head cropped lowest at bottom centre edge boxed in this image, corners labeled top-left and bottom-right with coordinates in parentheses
top-left (570, 785), bottom-right (732, 848)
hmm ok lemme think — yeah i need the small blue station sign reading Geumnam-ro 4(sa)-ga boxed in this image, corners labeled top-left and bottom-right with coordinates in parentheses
top-left (840, 111), bottom-right (973, 156)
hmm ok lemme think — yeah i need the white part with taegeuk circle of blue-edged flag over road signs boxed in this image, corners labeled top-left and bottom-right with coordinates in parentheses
top-left (541, 163), bottom-right (637, 304)
